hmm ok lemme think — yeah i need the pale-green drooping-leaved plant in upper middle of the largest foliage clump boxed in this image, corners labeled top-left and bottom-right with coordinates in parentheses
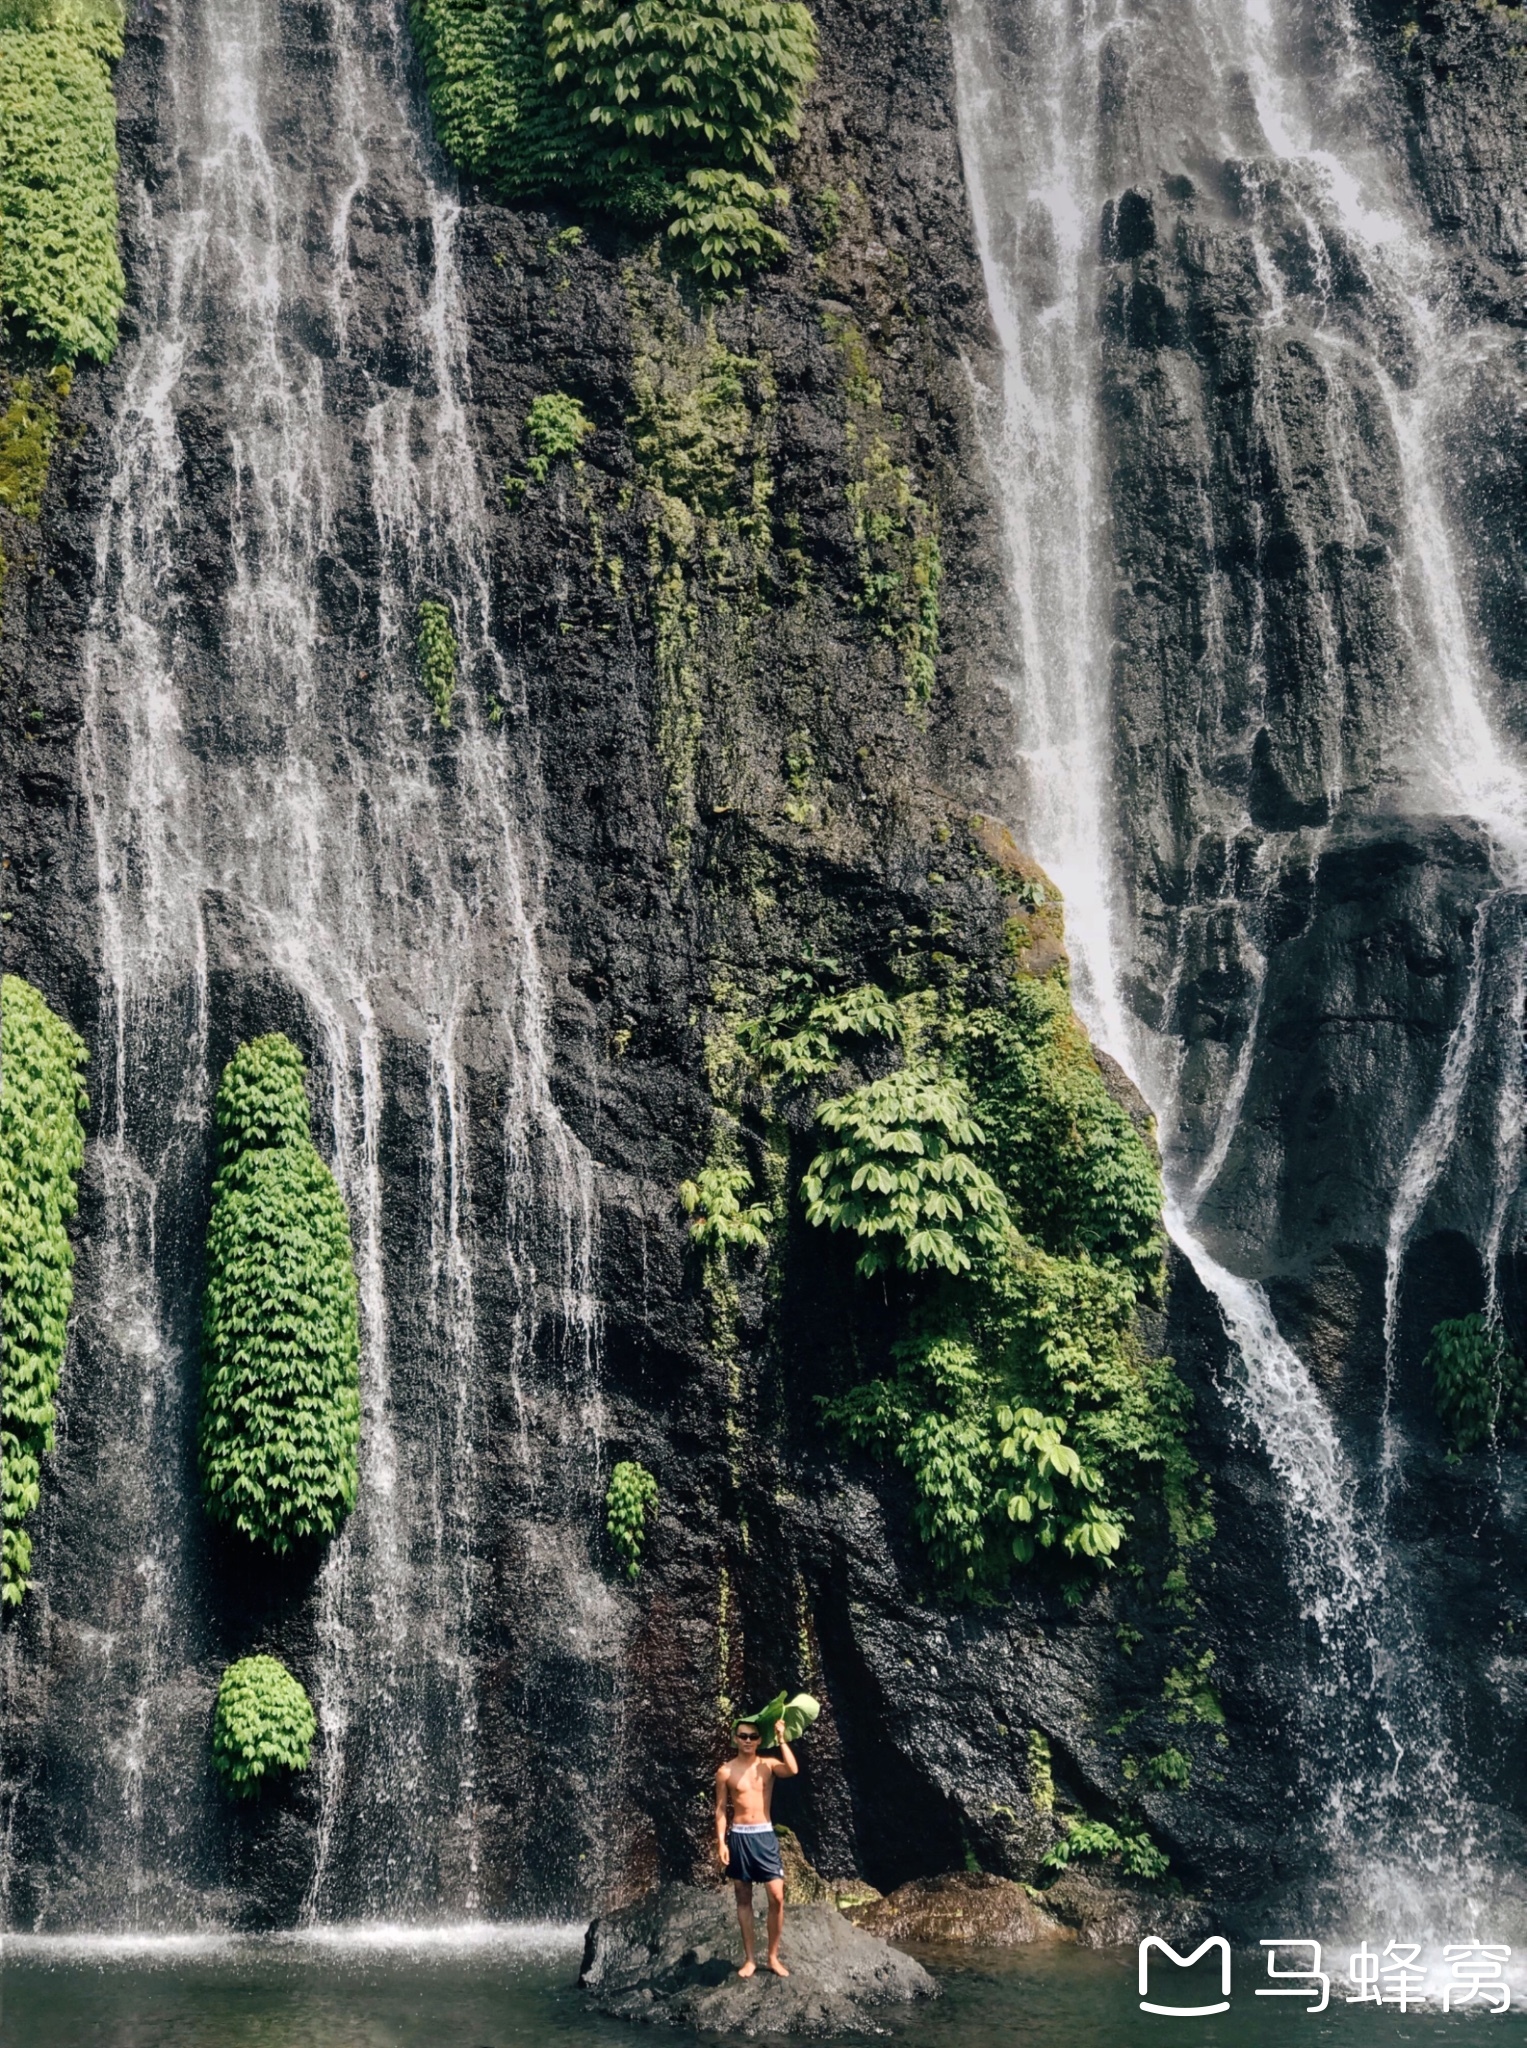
top-left (800, 1059), bottom-right (1007, 1278)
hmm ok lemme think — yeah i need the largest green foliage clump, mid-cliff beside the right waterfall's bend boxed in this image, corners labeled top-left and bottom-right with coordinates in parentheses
top-left (686, 933), bottom-right (1212, 1597)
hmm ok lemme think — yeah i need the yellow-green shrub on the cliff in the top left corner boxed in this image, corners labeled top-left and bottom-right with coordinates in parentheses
top-left (0, 0), bottom-right (125, 362)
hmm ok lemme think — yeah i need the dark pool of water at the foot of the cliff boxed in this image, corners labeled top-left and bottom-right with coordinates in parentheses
top-left (0, 1929), bottom-right (1527, 2048)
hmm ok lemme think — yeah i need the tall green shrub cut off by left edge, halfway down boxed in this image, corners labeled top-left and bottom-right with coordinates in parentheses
top-left (0, 975), bottom-right (86, 1608)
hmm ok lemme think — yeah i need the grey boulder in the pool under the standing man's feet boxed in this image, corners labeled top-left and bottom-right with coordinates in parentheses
top-left (577, 1884), bottom-right (937, 2034)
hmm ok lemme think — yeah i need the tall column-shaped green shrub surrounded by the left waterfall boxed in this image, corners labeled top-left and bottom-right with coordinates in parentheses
top-left (201, 1034), bottom-right (360, 1552)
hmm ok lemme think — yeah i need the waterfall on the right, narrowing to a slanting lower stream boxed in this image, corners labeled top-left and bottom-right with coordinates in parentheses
top-left (954, 0), bottom-right (1527, 1939)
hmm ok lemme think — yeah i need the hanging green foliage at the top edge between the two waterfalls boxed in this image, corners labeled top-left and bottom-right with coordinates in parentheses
top-left (409, 0), bottom-right (817, 283)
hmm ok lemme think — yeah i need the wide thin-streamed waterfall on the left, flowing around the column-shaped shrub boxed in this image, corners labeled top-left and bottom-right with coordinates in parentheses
top-left (8, 0), bottom-right (622, 1929)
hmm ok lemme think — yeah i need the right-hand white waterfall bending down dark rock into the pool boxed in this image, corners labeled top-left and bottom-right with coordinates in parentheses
top-left (954, 0), bottom-right (1527, 1939)
